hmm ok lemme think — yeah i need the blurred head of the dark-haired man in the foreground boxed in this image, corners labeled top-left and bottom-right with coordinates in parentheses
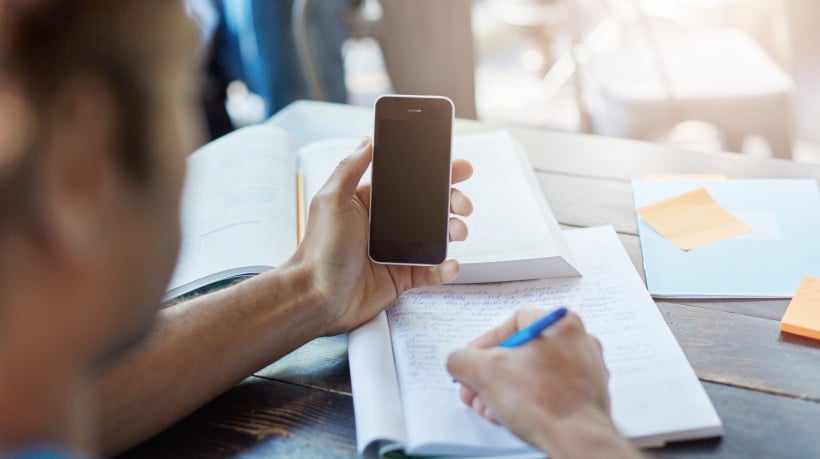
top-left (0, 0), bottom-right (199, 374)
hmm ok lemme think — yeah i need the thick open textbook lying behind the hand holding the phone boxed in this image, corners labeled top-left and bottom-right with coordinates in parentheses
top-left (166, 125), bottom-right (578, 299)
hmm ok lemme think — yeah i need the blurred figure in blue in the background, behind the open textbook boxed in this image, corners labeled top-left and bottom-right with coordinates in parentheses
top-left (186, 0), bottom-right (350, 138)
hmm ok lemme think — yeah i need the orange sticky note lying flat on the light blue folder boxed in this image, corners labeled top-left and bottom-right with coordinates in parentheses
top-left (637, 188), bottom-right (752, 250)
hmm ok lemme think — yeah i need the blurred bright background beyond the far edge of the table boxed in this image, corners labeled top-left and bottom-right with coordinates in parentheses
top-left (188, 0), bottom-right (820, 163)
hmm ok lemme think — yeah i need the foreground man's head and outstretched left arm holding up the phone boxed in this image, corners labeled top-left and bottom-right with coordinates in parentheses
top-left (0, 0), bottom-right (471, 458)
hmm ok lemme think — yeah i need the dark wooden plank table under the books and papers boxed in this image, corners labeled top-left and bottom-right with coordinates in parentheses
top-left (124, 102), bottom-right (820, 458)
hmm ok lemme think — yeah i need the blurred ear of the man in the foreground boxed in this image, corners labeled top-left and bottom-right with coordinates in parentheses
top-left (37, 75), bottom-right (124, 262)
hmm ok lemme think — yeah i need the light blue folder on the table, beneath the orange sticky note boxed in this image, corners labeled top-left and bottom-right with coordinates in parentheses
top-left (632, 180), bottom-right (820, 298)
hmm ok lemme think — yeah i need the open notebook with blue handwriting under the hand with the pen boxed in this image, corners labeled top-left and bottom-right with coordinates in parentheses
top-left (348, 227), bottom-right (722, 457)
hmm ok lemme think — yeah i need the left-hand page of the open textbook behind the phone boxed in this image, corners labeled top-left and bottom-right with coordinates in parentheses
top-left (166, 125), bottom-right (296, 298)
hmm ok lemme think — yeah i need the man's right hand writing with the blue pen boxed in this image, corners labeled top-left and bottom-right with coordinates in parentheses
top-left (447, 309), bottom-right (637, 457)
